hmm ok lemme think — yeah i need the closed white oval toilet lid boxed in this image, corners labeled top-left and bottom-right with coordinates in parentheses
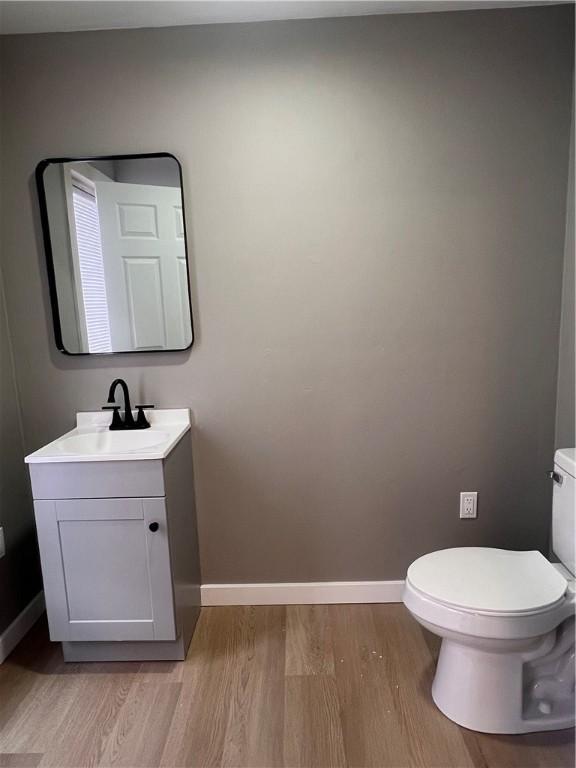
top-left (407, 547), bottom-right (567, 613)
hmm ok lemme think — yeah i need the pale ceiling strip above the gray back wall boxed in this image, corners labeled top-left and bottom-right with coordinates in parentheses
top-left (0, 0), bottom-right (574, 35)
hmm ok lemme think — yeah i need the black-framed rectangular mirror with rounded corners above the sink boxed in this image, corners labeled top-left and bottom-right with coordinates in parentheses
top-left (36, 152), bottom-right (194, 355)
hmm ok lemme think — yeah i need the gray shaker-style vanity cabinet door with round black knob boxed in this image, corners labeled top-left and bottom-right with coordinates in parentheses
top-left (34, 498), bottom-right (176, 641)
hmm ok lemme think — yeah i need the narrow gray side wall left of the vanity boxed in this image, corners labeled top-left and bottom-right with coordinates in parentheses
top-left (0, 273), bottom-right (42, 634)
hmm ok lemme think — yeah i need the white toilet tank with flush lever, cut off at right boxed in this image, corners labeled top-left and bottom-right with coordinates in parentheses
top-left (552, 448), bottom-right (576, 574)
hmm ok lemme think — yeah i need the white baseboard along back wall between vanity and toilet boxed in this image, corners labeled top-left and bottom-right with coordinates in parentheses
top-left (201, 581), bottom-right (404, 605)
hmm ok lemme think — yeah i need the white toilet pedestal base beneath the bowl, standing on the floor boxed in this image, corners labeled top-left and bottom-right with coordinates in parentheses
top-left (432, 622), bottom-right (574, 734)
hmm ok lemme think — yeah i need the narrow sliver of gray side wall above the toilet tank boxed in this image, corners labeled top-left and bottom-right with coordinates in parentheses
top-left (556, 116), bottom-right (576, 448)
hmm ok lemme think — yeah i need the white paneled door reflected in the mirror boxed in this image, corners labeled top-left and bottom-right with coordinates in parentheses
top-left (95, 181), bottom-right (190, 350)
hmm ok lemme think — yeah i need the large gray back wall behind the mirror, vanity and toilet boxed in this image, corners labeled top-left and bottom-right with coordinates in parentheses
top-left (2, 7), bottom-right (573, 582)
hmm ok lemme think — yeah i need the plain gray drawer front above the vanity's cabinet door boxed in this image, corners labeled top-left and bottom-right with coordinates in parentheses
top-left (29, 460), bottom-right (165, 499)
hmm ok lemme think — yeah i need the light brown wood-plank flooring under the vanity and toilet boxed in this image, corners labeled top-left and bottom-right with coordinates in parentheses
top-left (0, 605), bottom-right (574, 768)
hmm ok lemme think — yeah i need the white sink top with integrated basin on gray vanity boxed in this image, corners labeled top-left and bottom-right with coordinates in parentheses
top-left (26, 408), bottom-right (190, 464)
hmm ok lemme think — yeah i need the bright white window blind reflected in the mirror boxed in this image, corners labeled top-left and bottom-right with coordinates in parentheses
top-left (72, 187), bottom-right (112, 352)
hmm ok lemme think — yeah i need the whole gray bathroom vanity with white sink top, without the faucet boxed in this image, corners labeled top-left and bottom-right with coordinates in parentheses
top-left (26, 409), bottom-right (200, 661)
